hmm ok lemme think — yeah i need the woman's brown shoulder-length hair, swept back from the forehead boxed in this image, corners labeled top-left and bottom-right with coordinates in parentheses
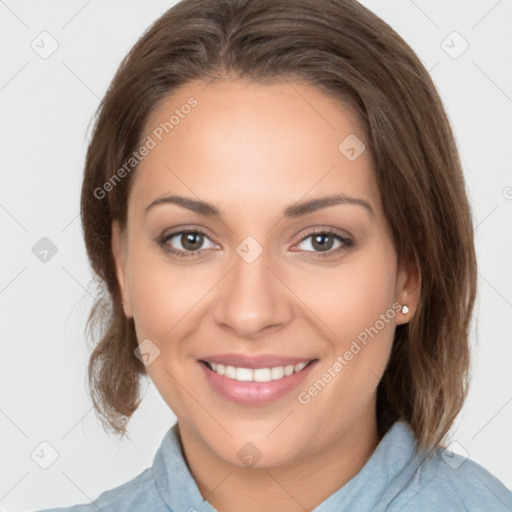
top-left (81, 0), bottom-right (476, 448)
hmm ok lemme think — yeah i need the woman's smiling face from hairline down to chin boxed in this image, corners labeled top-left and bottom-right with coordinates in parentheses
top-left (113, 79), bottom-right (417, 467)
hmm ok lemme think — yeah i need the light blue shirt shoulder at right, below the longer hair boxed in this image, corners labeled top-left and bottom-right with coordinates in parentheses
top-left (389, 447), bottom-right (512, 512)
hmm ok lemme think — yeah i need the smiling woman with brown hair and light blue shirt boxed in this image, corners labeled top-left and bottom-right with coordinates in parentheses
top-left (38, 0), bottom-right (512, 512)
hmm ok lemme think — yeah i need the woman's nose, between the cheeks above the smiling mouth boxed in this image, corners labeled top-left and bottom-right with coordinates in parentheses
top-left (214, 247), bottom-right (293, 339)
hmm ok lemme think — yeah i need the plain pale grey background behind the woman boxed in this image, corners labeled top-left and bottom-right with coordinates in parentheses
top-left (0, 0), bottom-right (512, 510)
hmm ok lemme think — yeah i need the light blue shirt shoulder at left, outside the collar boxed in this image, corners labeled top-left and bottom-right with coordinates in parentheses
top-left (32, 467), bottom-right (169, 512)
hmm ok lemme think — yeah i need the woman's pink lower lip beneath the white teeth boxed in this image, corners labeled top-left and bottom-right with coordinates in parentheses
top-left (198, 360), bottom-right (317, 405)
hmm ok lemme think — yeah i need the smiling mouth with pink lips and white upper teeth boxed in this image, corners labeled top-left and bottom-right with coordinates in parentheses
top-left (197, 356), bottom-right (319, 406)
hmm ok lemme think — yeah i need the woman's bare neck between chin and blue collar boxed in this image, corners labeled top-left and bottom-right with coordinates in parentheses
top-left (179, 407), bottom-right (380, 512)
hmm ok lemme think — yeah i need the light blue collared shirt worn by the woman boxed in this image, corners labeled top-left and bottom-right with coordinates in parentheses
top-left (37, 421), bottom-right (512, 512)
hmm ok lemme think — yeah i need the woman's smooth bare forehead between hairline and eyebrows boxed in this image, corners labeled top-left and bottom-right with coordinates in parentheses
top-left (130, 80), bottom-right (380, 220)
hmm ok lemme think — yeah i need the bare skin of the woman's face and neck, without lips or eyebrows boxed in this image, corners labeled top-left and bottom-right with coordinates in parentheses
top-left (112, 78), bottom-right (419, 512)
